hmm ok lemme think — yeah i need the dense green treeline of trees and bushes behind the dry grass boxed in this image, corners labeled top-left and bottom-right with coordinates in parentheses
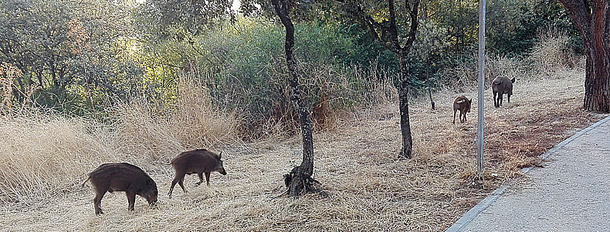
top-left (0, 0), bottom-right (582, 132)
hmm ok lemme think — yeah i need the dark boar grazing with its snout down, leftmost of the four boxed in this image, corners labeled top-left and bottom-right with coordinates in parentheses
top-left (82, 163), bottom-right (158, 215)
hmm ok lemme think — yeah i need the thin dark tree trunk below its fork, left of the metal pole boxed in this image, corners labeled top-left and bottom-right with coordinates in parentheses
top-left (398, 52), bottom-right (413, 159)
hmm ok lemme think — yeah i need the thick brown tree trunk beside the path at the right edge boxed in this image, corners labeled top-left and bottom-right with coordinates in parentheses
top-left (560, 0), bottom-right (610, 113)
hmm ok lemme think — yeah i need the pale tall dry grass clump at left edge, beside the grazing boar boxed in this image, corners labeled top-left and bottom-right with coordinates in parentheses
top-left (0, 113), bottom-right (123, 203)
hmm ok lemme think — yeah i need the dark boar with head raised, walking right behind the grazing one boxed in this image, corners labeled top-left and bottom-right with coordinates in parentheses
top-left (167, 149), bottom-right (227, 198)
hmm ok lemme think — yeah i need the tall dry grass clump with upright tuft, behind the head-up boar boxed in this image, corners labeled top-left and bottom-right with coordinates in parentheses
top-left (115, 76), bottom-right (241, 163)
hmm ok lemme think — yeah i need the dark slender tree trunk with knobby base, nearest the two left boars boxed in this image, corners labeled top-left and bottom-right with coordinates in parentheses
top-left (271, 0), bottom-right (319, 197)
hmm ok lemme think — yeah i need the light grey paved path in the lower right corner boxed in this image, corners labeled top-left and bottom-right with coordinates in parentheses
top-left (447, 117), bottom-right (610, 231)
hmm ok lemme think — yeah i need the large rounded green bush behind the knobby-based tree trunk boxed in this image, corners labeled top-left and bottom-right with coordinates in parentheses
top-left (185, 19), bottom-right (382, 136)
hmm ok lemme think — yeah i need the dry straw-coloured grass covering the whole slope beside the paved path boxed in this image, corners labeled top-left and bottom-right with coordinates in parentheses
top-left (0, 61), bottom-right (601, 231)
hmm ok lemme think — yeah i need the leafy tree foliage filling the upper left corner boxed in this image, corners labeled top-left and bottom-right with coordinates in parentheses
top-left (0, 0), bottom-right (137, 113)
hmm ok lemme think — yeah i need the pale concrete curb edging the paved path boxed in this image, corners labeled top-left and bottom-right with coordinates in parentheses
top-left (445, 116), bottom-right (610, 232)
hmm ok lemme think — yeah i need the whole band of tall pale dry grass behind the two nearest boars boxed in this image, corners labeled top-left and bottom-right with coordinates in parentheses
top-left (0, 74), bottom-right (240, 204)
